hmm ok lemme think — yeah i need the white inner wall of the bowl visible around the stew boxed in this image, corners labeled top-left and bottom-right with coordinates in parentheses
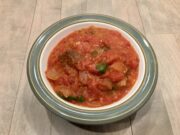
top-left (40, 22), bottom-right (145, 110)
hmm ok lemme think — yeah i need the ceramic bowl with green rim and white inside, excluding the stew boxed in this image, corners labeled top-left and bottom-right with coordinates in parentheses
top-left (27, 14), bottom-right (158, 124)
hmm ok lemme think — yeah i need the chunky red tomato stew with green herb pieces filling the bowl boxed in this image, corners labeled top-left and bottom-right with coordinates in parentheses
top-left (46, 26), bottom-right (139, 107)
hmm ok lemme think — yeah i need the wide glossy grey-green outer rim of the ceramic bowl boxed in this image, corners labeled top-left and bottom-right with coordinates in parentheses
top-left (27, 14), bottom-right (158, 125)
